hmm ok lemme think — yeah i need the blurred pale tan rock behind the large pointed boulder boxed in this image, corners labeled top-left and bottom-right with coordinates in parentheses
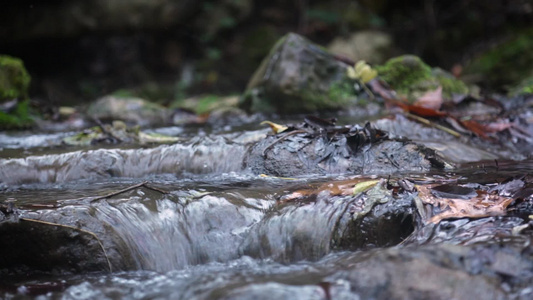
top-left (328, 31), bottom-right (393, 64)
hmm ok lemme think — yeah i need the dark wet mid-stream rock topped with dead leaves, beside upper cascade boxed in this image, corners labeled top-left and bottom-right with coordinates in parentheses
top-left (245, 120), bottom-right (447, 177)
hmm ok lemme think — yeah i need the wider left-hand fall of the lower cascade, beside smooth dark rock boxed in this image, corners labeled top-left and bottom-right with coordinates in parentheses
top-left (95, 194), bottom-right (268, 271)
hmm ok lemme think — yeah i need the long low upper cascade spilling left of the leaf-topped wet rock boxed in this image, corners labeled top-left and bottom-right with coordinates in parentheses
top-left (0, 136), bottom-right (247, 185)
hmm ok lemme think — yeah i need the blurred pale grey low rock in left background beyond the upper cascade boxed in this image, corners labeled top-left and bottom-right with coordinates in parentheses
top-left (87, 96), bottom-right (171, 126)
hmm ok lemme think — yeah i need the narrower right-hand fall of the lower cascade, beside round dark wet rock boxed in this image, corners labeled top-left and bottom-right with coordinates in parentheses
top-left (242, 193), bottom-right (354, 263)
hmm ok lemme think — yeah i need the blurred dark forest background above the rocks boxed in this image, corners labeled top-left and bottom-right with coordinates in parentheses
top-left (0, 0), bottom-right (533, 104)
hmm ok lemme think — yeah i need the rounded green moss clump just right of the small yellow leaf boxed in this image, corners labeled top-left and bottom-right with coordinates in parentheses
top-left (376, 55), bottom-right (431, 94)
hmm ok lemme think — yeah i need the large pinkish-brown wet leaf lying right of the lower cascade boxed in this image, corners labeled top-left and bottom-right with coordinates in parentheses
top-left (416, 185), bottom-right (514, 224)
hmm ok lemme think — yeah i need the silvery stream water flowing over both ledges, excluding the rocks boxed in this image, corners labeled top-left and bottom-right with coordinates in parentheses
top-left (0, 118), bottom-right (533, 299)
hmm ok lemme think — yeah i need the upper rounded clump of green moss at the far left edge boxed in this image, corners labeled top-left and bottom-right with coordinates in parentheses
top-left (0, 55), bottom-right (31, 101)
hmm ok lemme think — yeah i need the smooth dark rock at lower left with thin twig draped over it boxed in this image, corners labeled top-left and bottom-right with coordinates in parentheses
top-left (0, 208), bottom-right (116, 276)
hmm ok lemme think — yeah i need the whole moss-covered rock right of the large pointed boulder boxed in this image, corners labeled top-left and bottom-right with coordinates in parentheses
top-left (376, 55), bottom-right (468, 101)
